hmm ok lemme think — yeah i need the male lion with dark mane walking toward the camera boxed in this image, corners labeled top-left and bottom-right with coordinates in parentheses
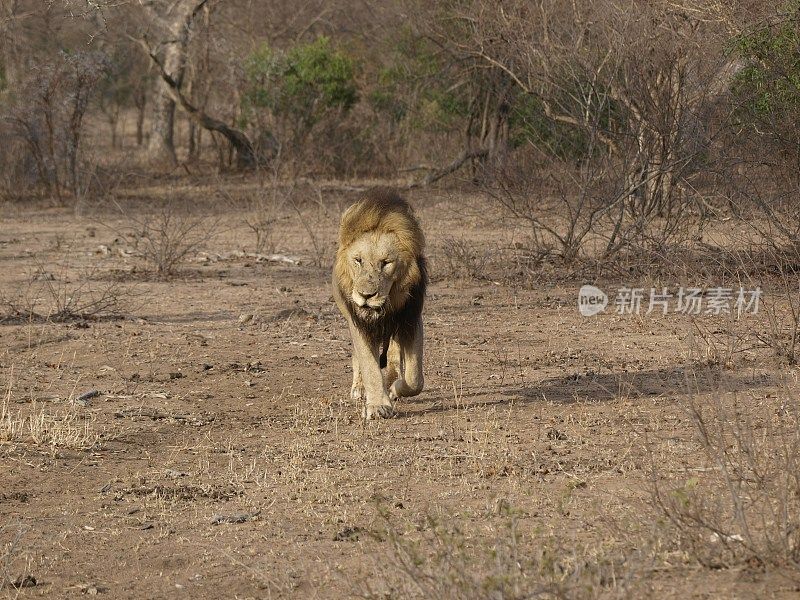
top-left (333, 188), bottom-right (428, 419)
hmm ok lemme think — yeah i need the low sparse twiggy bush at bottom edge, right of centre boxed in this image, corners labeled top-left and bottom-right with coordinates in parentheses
top-left (360, 499), bottom-right (640, 600)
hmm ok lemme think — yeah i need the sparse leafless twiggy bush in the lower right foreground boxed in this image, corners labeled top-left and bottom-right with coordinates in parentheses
top-left (653, 376), bottom-right (800, 579)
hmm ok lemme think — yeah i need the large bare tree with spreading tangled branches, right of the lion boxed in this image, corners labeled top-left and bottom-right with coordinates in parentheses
top-left (458, 0), bottom-right (732, 203)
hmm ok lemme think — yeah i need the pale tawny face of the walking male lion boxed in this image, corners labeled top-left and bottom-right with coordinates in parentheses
top-left (347, 232), bottom-right (404, 316)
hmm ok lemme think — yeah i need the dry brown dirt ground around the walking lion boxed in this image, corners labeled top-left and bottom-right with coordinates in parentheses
top-left (0, 183), bottom-right (798, 598)
